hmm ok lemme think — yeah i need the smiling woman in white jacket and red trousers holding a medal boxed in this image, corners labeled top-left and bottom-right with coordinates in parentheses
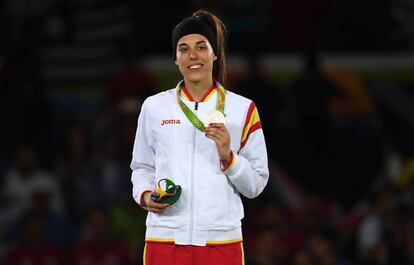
top-left (131, 10), bottom-right (269, 265)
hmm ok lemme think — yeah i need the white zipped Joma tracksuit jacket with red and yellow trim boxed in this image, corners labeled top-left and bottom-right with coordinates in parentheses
top-left (131, 83), bottom-right (269, 246)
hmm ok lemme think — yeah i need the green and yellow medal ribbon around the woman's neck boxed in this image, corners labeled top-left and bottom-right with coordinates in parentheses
top-left (177, 81), bottom-right (226, 132)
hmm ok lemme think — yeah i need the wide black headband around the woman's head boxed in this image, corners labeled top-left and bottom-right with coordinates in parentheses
top-left (172, 16), bottom-right (218, 59)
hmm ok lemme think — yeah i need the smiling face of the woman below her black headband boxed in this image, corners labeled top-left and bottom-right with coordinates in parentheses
top-left (175, 34), bottom-right (217, 83)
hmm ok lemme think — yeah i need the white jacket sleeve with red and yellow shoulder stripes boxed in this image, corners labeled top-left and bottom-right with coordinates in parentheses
top-left (222, 102), bottom-right (269, 199)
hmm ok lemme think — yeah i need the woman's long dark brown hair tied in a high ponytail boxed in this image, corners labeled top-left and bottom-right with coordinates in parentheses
top-left (173, 9), bottom-right (227, 87)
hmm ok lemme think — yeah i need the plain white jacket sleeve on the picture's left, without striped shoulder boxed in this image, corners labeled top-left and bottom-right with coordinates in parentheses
top-left (130, 100), bottom-right (155, 205)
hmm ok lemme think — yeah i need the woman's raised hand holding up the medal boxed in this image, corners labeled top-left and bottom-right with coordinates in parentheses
top-left (204, 123), bottom-right (230, 161)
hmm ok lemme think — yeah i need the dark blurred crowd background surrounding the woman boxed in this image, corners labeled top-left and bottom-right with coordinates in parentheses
top-left (0, 0), bottom-right (414, 265)
